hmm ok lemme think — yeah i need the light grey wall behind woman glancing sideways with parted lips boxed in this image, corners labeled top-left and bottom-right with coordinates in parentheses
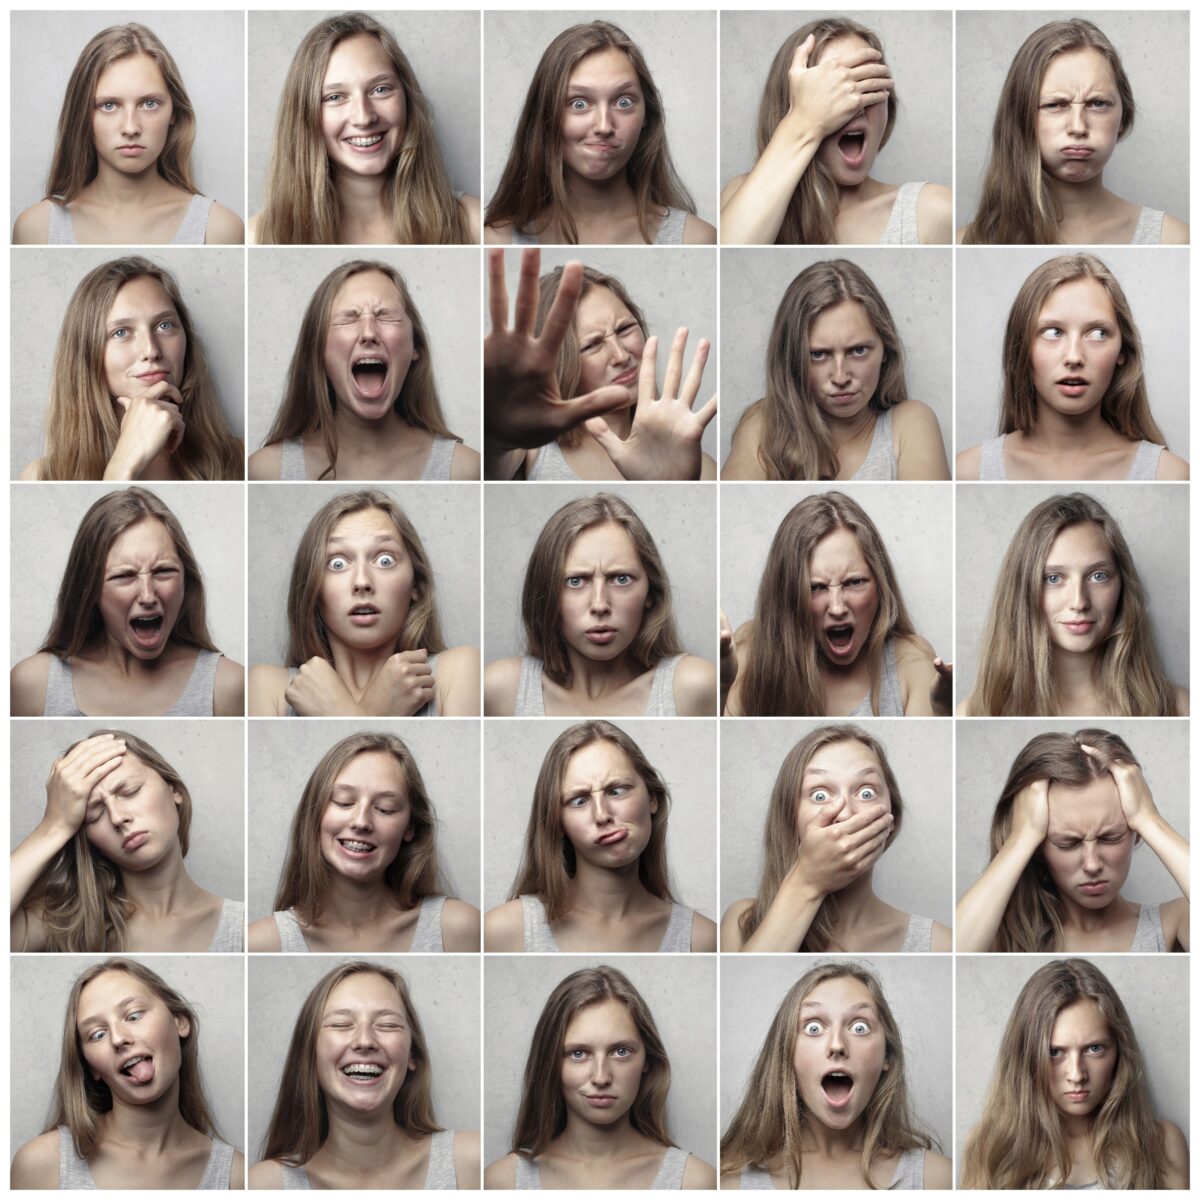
top-left (955, 246), bottom-right (1188, 458)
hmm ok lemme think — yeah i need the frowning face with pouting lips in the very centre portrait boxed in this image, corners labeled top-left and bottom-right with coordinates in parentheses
top-left (559, 521), bottom-right (649, 662)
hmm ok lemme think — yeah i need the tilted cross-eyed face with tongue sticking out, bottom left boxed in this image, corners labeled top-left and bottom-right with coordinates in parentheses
top-left (76, 971), bottom-right (191, 1104)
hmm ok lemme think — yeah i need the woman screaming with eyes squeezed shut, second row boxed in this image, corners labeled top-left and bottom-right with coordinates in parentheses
top-left (250, 259), bottom-right (479, 480)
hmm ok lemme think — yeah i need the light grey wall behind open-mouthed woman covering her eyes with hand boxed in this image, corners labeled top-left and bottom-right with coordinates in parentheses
top-left (721, 8), bottom-right (953, 196)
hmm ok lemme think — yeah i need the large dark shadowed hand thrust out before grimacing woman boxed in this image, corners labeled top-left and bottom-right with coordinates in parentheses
top-left (484, 250), bottom-right (629, 454)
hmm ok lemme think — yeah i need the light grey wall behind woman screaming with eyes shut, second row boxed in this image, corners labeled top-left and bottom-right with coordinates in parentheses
top-left (246, 246), bottom-right (482, 452)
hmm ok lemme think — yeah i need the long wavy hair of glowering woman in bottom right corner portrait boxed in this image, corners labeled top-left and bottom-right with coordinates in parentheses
top-left (959, 959), bottom-right (1166, 1190)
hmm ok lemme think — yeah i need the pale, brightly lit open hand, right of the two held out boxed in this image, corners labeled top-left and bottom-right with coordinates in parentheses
top-left (584, 329), bottom-right (716, 479)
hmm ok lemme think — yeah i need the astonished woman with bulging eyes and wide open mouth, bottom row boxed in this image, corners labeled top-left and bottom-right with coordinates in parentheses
top-left (721, 960), bottom-right (950, 1190)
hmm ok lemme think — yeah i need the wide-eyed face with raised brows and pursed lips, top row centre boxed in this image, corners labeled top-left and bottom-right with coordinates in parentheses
top-left (563, 47), bottom-right (646, 182)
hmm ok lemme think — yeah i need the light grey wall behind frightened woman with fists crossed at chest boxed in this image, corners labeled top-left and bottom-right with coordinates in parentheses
top-left (250, 484), bottom-right (479, 662)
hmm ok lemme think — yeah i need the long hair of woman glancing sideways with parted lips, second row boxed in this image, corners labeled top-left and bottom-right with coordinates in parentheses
top-left (1000, 253), bottom-right (1165, 445)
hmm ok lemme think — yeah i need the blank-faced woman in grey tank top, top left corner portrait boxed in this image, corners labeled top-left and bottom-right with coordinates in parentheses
top-left (12, 23), bottom-right (245, 246)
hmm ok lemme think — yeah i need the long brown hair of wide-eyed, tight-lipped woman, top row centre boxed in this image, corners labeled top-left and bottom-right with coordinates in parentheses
top-left (484, 20), bottom-right (696, 246)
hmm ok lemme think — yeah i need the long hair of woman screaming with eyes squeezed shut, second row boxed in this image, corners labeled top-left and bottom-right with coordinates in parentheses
top-left (264, 258), bottom-right (454, 479)
